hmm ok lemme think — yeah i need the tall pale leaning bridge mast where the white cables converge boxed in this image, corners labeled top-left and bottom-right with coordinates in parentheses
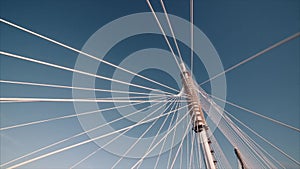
top-left (180, 63), bottom-right (216, 169)
